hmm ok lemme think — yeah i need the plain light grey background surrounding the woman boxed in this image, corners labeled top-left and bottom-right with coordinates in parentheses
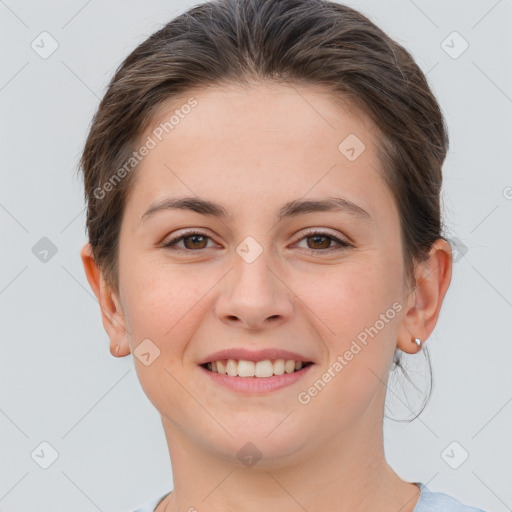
top-left (0, 0), bottom-right (512, 512)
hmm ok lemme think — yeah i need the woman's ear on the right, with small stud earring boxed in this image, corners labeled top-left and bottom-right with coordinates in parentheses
top-left (398, 238), bottom-right (452, 353)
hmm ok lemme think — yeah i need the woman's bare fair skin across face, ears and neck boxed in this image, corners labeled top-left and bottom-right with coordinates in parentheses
top-left (81, 83), bottom-right (452, 512)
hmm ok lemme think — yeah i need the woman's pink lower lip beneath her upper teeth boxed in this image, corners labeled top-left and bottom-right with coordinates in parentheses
top-left (199, 364), bottom-right (313, 394)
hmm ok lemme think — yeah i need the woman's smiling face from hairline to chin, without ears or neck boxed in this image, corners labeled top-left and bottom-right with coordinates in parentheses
top-left (113, 85), bottom-right (412, 462)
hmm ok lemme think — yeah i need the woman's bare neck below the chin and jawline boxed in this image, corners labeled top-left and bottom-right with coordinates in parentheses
top-left (158, 410), bottom-right (419, 512)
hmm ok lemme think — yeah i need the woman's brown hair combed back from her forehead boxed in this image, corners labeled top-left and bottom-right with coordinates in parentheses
top-left (76, 0), bottom-right (448, 418)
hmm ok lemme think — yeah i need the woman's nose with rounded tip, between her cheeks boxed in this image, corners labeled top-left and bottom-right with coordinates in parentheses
top-left (215, 247), bottom-right (295, 330)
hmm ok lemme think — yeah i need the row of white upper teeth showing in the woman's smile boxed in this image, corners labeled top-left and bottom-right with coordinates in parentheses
top-left (206, 359), bottom-right (303, 377)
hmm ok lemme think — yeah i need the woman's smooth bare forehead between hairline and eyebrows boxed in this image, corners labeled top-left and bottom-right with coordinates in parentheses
top-left (125, 83), bottom-right (391, 226)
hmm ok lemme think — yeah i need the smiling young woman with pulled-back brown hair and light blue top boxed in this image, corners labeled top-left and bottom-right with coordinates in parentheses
top-left (81, 0), bottom-right (488, 512)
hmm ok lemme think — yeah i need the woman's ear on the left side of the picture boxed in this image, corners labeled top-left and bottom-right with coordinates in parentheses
top-left (80, 243), bottom-right (130, 357)
